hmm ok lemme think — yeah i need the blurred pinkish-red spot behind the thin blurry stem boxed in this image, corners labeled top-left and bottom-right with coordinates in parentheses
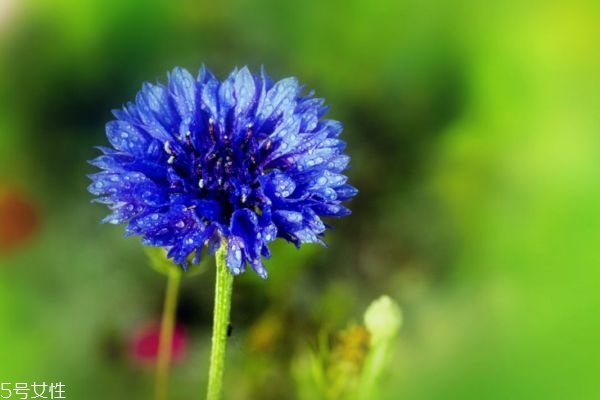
top-left (129, 323), bottom-right (187, 364)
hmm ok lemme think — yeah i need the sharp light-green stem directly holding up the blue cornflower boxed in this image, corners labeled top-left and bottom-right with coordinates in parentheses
top-left (206, 242), bottom-right (233, 400)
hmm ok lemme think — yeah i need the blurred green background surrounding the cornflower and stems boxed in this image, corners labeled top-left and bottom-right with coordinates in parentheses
top-left (0, 0), bottom-right (600, 399)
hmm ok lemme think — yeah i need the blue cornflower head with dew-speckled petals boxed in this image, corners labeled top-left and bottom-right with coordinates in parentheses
top-left (88, 67), bottom-right (357, 278)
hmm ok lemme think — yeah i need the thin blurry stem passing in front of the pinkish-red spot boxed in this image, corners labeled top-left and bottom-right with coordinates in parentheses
top-left (155, 270), bottom-right (181, 400)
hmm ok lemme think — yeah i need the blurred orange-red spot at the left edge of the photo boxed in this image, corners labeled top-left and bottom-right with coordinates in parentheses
top-left (0, 185), bottom-right (39, 253)
